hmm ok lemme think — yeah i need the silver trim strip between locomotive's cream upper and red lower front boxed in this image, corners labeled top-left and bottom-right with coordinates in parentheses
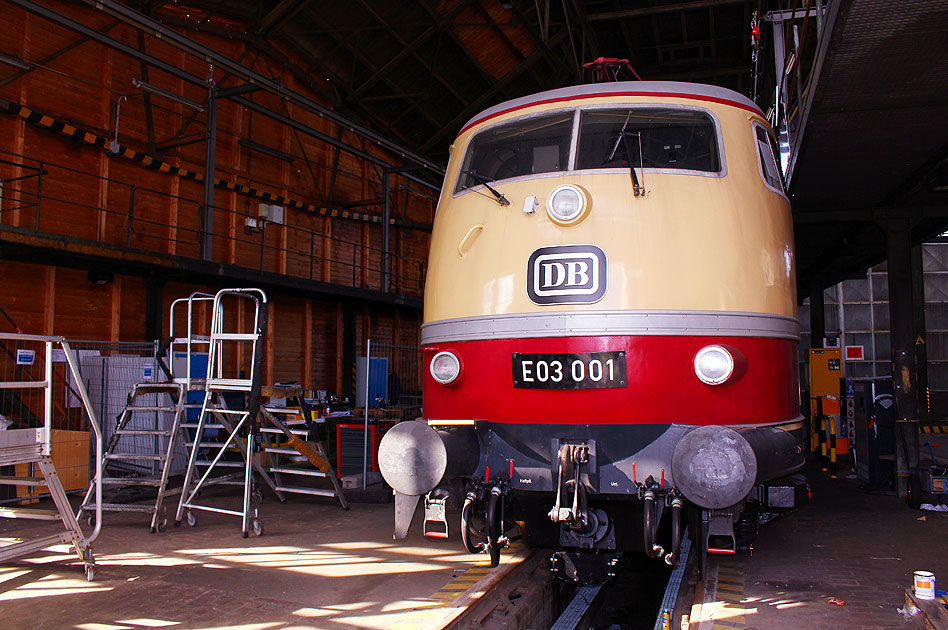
top-left (421, 310), bottom-right (800, 344)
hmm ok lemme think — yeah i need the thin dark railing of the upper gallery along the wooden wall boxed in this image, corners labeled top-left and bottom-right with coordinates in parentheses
top-left (0, 150), bottom-right (426, 296)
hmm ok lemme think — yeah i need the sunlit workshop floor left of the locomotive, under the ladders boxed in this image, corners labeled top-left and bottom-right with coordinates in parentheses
top-left (0, 496), bottom-right (523, 630)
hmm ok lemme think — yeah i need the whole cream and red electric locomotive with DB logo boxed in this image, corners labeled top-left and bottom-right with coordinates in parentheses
top-left (378, 81), bottom-right (803, 581)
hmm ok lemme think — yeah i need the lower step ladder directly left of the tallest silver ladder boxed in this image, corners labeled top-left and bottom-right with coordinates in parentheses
top-left (79, 382), bottom-right (188, 534)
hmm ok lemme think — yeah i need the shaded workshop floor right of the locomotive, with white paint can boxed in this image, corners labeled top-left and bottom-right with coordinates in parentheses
top-left (691, 444), bottom-right (948, 630)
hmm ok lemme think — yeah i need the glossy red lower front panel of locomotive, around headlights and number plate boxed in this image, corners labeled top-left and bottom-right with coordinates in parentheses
top-left (424, 336), bottom-right (799, 424)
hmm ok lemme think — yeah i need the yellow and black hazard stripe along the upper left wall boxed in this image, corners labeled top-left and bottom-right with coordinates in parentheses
top-left (0, 98), bottom-right (431, 230)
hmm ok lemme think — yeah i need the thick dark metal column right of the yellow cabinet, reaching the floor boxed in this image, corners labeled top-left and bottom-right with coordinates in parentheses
top-left (886, 219), bottom-right (918, 498)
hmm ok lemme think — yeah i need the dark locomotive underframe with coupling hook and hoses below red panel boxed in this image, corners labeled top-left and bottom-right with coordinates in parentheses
top-left (418, 422), bottom-right (805, 582)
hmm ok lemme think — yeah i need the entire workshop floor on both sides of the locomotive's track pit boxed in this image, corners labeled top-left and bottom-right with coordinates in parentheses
top-left (7, 435), bottom-right (948, 630)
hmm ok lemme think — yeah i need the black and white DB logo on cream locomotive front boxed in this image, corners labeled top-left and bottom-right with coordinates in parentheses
top-left (527, 245), bottom-right (606, 304)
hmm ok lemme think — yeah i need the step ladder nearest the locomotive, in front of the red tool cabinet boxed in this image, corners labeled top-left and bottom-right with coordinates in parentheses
top-left (260, 385), bottom-right (349, 510)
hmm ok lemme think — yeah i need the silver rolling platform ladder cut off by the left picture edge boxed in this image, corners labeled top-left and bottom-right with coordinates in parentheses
top-left (0, 334), bottom-right (102, 580)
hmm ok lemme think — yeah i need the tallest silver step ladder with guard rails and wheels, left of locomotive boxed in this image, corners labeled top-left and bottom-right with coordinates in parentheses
top-left (175, 289), bottom-right (286, 538)
